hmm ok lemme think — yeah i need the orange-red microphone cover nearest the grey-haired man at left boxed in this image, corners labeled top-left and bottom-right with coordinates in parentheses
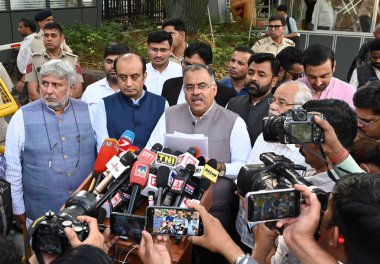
top-left (94, 138), bottom-right (119, 174)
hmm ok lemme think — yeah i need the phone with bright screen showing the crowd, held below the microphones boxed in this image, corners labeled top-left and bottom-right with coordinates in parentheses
top-left (145, 206), bottom-right (203, 236)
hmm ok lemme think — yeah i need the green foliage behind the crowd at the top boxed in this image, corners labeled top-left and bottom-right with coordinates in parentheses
top-left (64, 19), bottom-right (256, 79)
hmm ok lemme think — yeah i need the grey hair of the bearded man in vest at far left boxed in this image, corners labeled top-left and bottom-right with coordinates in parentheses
top-left (40, 59), bottom-right (76, 86)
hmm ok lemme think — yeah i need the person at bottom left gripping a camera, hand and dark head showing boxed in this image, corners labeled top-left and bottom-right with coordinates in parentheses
top-left (29, 216), bottom-right (118, 264)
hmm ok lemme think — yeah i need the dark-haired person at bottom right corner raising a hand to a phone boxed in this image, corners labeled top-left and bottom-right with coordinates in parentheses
top-left (277, 173), bottom-right (380, 264)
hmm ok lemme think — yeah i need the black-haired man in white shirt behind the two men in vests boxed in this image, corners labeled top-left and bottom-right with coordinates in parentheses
top-left (144, 31), bottom-right (182, 95)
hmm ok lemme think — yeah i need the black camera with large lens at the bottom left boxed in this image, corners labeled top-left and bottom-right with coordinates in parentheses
top-left (32, 191), bottom-right (97, 255)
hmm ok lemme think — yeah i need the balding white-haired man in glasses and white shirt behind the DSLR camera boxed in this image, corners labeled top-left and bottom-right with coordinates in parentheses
top-left (233, 81), bottom-right (313, 252)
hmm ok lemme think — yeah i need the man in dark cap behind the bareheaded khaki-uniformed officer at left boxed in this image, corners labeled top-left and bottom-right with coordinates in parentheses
top-left (27, 9), bottom-right (73, 61)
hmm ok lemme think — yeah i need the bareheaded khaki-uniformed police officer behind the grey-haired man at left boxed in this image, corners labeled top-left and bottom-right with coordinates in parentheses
top-left (25, 22), bottom-right (83, 101)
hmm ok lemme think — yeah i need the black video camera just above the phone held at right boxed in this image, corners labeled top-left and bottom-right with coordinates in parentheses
top-left (237, 152), bottom-right (328, 222)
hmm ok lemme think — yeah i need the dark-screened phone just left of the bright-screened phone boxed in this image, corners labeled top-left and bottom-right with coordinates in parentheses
top-left (110, 212), bottom-right (145, 243)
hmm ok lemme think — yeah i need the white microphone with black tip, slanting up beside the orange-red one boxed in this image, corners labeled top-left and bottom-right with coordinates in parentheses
top-left (93, 152), bottom-right (136, 195)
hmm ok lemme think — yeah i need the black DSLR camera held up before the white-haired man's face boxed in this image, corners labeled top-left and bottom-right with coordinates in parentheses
top-left (263, 108), bottom-right (324, 144)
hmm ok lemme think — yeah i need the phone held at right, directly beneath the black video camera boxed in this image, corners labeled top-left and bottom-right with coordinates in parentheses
top-left (245, 188), bottom-right (301, 222)
